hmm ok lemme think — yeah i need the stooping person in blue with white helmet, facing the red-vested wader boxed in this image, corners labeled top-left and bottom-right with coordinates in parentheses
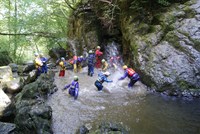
top-left (94, 72), bottom-right (113, 91)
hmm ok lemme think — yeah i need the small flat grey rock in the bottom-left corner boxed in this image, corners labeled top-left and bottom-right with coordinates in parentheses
top-left (0, 122), bottom-right (16, 134)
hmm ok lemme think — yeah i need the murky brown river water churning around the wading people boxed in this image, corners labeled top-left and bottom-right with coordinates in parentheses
top-left (47, 68), bottom-right (200, 134)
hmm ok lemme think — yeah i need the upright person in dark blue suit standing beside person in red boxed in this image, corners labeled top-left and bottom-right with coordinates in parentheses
top-left (87, 50), bottom-right (95, 76)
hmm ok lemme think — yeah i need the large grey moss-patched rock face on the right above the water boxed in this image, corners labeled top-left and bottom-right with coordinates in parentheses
top-left (120, 1), bottom-right (200, 91)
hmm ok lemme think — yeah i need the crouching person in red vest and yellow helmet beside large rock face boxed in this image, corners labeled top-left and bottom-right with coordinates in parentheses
top-left (118, 65), bottom-right (140, 88)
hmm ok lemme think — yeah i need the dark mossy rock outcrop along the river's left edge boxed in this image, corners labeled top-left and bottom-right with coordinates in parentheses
top-left (14, 72), bottom-right (57, 134)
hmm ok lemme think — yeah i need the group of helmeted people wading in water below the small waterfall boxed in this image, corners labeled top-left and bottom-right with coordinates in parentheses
top-left (59, 46), bottom-right (140, 99)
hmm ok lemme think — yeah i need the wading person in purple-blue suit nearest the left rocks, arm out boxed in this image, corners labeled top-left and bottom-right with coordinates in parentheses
top-left (62, 76), bottom-right (79, 100)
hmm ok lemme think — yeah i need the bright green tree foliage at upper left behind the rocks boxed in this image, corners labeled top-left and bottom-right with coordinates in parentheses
top-left (0, 0), bottom-right (80, 62)
